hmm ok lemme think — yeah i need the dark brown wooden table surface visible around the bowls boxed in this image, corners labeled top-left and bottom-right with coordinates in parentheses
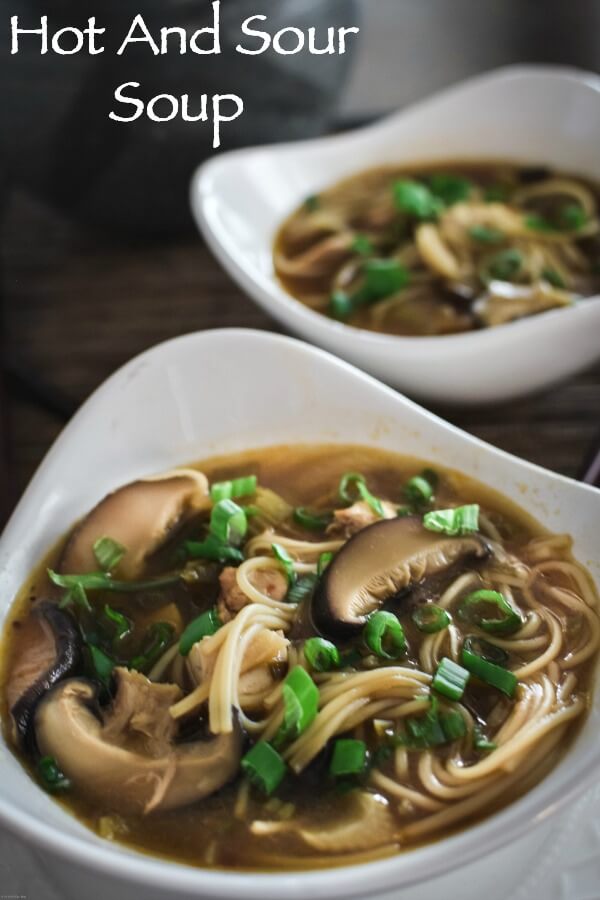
top-left (0, 194), bottom-right (600, 528)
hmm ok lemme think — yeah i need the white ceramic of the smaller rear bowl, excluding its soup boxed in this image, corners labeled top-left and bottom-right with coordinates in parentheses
top-left (191, 66), bottom-right (600, 403)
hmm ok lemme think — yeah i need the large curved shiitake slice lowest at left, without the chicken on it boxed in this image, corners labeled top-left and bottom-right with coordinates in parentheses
top-left (35, 679), bottom-right (244, 814)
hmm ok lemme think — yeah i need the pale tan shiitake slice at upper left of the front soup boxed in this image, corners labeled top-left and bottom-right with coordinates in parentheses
top-left (58, 469), bottom-right (209, 579)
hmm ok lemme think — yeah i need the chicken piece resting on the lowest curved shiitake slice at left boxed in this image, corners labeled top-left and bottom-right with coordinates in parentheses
top-left (102, 667), bottom-right (182, 758)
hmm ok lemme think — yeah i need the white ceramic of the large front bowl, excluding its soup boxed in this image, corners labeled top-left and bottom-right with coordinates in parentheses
top-left (0, 330), bottom-right (600, 900)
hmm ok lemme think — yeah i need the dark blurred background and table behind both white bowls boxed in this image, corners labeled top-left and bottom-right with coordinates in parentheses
top-left (0, 0), bottom-right (600, 524)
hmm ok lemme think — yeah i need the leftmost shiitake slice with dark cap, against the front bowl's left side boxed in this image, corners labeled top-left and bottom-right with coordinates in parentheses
top-left (6, 601), bottom-right (81, 745)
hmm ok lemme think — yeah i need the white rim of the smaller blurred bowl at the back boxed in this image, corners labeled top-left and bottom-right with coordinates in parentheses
top-left (189, 63), bottom-right (600, 353)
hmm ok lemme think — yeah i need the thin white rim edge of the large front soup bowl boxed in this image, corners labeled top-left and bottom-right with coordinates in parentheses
top-left (0, 328), bottom-right (600, 900)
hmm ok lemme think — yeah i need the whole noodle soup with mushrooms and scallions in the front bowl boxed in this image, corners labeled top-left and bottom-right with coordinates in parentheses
top-left (3, 446), bottom-right (600, 870)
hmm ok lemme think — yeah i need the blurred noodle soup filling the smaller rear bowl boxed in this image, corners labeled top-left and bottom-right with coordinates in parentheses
top-left (275, 162), bottom-right (600, 336)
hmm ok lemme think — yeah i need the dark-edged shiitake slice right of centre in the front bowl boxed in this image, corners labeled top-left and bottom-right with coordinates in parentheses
top-left (312, 516), bottom-right (489, 637)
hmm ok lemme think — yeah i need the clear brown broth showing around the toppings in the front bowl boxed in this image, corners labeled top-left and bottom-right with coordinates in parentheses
top-left (1, 445), bottom-right (595, 870)
